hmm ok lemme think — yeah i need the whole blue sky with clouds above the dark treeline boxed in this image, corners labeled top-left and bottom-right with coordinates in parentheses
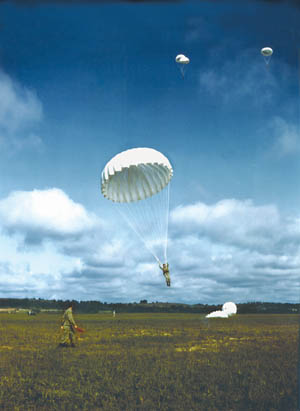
top-left (0, 0), bottom-right (300, 304)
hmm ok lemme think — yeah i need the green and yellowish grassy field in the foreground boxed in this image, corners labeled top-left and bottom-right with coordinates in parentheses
top-left (0, 312), bottom-right (298, 411)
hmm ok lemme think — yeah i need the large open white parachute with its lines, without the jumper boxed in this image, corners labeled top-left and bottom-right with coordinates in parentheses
top-left (101, 147), bottom-right (173, 262)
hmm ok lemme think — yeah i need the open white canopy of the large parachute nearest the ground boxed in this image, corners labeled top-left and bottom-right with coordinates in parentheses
top-left (101, 148), bottom-right (173, 203)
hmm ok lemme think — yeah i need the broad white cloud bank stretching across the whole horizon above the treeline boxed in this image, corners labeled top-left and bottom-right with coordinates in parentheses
top-left (0, 189), bottom-right (300, 304)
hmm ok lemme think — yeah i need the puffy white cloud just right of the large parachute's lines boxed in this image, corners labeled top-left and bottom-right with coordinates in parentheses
top-left (171, 199), bottom-right (280, 253)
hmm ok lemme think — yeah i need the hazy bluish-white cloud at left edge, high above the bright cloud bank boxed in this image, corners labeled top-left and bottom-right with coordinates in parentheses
top-left (0, 70), bottom-right (43, 147)
